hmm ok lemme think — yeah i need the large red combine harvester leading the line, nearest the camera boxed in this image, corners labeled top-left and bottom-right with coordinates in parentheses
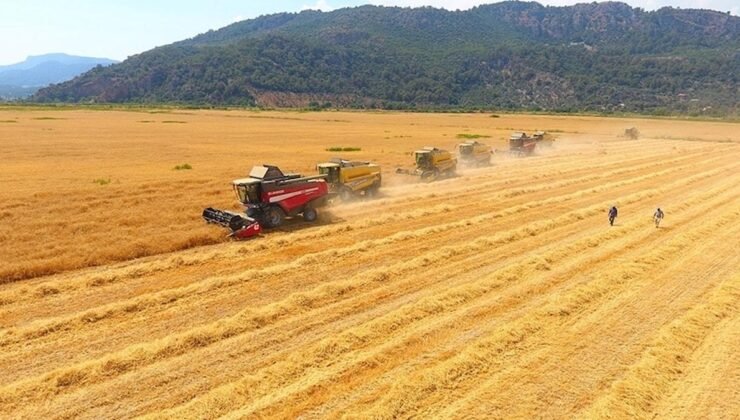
top-left (203, 165), bottom-right (329, 239)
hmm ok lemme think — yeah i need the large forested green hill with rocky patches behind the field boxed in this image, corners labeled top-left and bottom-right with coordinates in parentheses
top-left (34, 2), bottom-right (740, 115)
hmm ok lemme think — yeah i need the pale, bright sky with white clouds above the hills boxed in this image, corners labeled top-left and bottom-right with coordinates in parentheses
top-left (0, 0), bottom-right (740, 65)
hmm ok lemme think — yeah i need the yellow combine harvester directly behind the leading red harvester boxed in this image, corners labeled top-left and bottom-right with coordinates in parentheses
top-left (316, 158), bottom-right (381, 201)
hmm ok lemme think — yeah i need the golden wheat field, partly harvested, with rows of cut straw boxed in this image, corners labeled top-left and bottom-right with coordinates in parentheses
top-left (0, 108), bottom-right (740, 419)
